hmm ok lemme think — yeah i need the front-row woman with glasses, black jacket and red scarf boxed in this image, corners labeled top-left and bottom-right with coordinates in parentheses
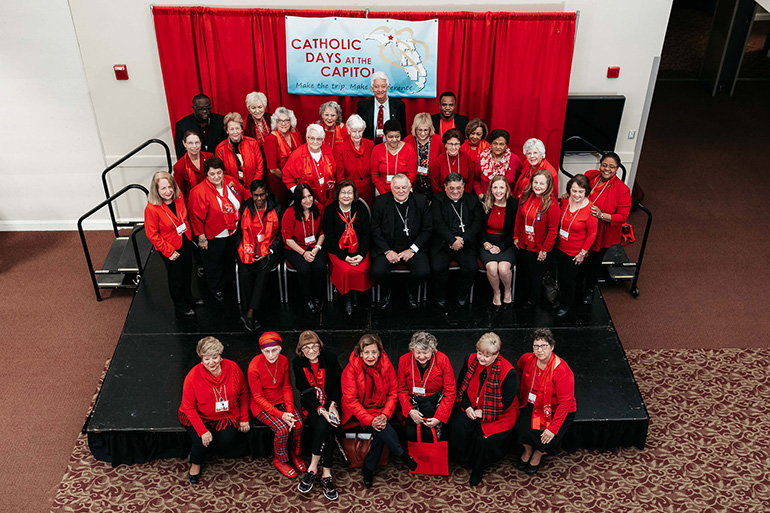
top-left (291, 330), bottom-right (342, 501)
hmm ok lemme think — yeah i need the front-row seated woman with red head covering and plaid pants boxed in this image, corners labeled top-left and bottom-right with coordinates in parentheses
top-left (247, 331), bottom-right (307, 478)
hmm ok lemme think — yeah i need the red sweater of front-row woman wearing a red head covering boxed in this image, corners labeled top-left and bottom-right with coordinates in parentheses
top-left (247, 353), bottom-right (294, 417)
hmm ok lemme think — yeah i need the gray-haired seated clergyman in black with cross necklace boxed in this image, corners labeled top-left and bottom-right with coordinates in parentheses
top-left (371, 173), bottom-right (433, 310)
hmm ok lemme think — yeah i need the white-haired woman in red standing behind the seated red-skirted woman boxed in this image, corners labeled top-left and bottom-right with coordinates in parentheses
top-left (334, 114), bottom-right (374, 208)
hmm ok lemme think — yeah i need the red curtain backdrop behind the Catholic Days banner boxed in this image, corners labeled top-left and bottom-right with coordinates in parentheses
top-left (153, 7), bottom-right (575, 158)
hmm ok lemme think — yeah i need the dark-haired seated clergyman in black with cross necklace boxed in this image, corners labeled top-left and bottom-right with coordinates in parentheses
top-left (430, 173), bottom-right (476, 308)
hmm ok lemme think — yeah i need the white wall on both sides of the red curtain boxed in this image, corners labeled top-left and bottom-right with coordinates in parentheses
top-left (0, 0), bottom-right (672, 229)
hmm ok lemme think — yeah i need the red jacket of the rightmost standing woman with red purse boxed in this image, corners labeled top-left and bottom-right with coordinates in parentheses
top-left (585, 169), bottom-right (631, 251)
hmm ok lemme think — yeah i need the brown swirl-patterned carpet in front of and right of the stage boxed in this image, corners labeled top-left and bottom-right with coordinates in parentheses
top-left (51, 348), bottom-right (770, 513)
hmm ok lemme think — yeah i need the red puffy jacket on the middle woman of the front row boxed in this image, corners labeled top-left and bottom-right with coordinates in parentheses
top-left (342, 351), bottom-right (398, 428)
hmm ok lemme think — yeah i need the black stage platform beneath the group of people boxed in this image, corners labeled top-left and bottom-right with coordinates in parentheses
top-left (83, 253), bottom-right (649, 465)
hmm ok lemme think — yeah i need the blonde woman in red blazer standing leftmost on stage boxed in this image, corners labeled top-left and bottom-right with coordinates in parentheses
top-left (144, 171), bottom-right (200, 317)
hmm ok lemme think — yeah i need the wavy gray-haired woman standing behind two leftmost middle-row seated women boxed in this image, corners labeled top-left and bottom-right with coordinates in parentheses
top-left (264, 107), bottom-right (302, 208)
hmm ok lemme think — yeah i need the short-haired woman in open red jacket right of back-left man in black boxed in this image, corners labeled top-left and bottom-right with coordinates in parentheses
top-left (215, 112), bottom-right (264, 189)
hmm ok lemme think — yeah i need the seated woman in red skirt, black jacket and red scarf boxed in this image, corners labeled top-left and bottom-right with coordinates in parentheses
top-left (323, 179), bottom-right (374, 315)
